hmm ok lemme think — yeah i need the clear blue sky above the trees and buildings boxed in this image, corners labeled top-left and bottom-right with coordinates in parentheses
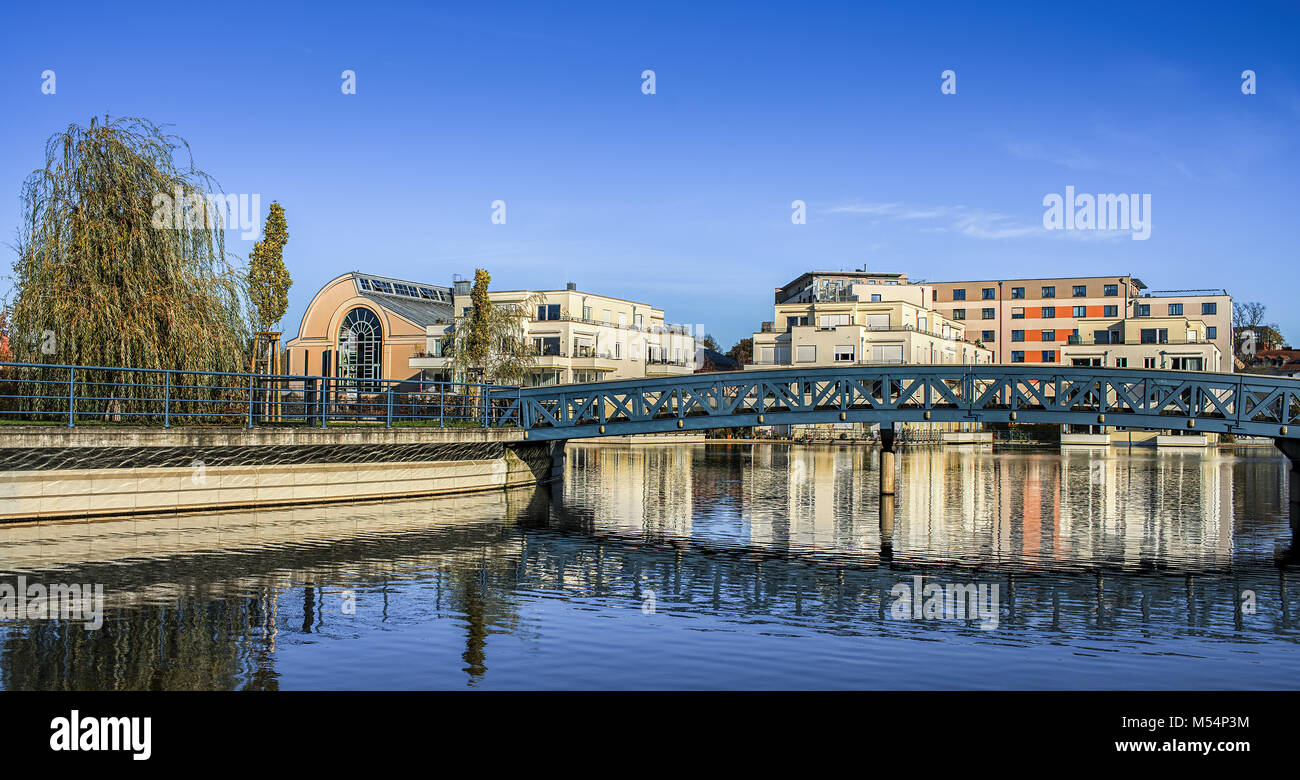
top-left (0, 3), bottom-right (1300, 347)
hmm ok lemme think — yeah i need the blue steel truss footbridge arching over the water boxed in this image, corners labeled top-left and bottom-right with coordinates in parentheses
top-left (491, 365), bottom-right (1300, 441)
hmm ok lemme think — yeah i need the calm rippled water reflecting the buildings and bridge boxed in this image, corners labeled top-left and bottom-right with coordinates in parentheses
top-left (0, 445), bottom-right (1300, 689)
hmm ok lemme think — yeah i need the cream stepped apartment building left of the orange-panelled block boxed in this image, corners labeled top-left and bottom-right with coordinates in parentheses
top-left (746, 270), bottom-right (993, 369)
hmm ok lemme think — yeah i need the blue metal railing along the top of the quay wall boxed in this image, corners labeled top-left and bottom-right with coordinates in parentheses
top-left (0, 363), bottom-right (517, 428)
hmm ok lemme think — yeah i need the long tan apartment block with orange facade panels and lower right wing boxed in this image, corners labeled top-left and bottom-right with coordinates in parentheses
top-left (928, 276), bottom-right (1232, 371)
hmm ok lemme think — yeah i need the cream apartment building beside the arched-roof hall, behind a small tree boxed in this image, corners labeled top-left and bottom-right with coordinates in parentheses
top-left (410, 281), bottom-right (696, 385)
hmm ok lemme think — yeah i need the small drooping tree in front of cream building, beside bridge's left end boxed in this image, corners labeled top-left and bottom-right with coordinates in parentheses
top-left (451, 268), bottom-right (540, 385)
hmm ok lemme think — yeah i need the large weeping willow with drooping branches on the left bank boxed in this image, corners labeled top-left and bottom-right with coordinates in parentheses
top-left (10, 117), bottom-right (251, 408)
